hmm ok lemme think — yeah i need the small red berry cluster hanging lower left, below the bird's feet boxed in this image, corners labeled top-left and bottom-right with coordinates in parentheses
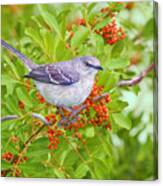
top-left (48, 126), bottom-right (63, 150)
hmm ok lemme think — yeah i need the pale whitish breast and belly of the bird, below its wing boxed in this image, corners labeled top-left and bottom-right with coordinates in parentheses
top-left (36, 78), bottom-right (94, 107)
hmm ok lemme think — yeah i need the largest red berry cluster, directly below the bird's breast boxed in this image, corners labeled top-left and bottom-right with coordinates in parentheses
top-left (66, 84), bottom-right (111, 133)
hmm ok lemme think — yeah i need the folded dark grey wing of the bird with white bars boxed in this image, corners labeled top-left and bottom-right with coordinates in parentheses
top-left (25, 64), bottom-right (80, 85)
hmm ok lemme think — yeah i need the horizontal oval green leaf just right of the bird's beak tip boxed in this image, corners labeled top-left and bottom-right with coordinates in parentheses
top-left (108, 58), bottom-right (130, 70)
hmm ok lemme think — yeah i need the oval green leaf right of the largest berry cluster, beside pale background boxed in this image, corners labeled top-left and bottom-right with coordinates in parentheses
top-left (112, 113), bottom-right (132, 130)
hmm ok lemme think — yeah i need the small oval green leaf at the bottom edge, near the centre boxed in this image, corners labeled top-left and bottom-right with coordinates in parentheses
top-left (74, 163), bottom-right (89, 179)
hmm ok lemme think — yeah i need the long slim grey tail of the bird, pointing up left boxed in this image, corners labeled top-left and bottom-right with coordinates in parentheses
top-left (1, 39), bottom-right (37, 70)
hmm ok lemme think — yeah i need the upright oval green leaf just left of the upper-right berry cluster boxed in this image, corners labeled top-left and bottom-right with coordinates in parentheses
top-left (71, 26), bottom-right (89, 48)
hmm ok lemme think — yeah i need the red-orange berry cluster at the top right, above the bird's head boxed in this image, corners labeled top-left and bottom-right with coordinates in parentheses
top-left (96, 19), bottom-right (126, 45)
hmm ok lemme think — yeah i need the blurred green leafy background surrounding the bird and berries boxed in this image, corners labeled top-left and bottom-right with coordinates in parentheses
top-left (1, 2), bottom-right (155, 180)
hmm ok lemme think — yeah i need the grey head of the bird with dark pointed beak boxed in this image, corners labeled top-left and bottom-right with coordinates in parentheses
top-left (76, 56), bottom-right (103, 74)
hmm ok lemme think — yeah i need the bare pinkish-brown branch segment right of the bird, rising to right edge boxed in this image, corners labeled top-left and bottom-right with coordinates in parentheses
top-left (118, 63), bottom-right (155, 87)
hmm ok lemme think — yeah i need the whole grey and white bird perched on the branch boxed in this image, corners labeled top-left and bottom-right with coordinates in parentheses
top-left (1, 40), bottom-right (102, 108)
